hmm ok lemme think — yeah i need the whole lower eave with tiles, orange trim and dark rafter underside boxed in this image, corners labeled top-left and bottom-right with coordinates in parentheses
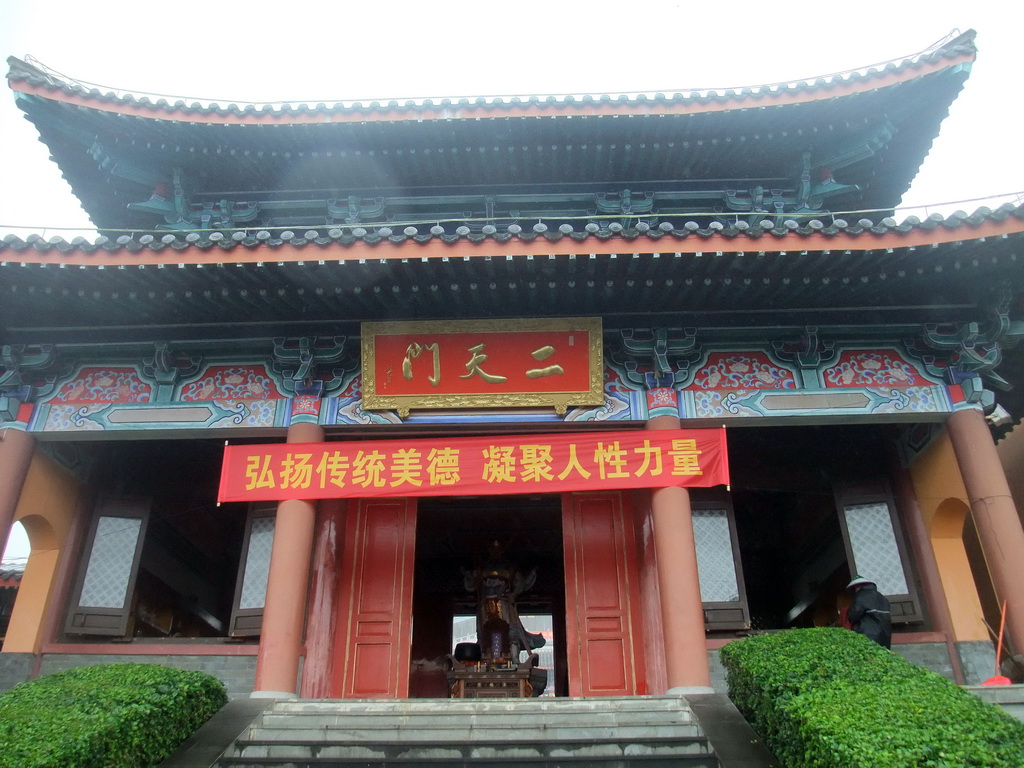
top-left (0, 206), bottom-right (1024, 343)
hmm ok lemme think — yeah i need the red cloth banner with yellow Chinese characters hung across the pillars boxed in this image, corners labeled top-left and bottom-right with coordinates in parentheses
top-left (218, 429), bottom-right (729, 502)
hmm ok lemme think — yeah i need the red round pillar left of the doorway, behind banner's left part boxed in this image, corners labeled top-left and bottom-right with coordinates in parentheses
top-left (253, 423), bottom-right (324, 698)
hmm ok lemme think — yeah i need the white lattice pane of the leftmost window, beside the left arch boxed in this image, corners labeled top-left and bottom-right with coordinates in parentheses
top-left (79, 517), bottom-right (142, 608)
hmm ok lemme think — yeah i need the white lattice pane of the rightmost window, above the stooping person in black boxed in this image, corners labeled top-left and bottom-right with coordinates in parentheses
top-left (843, 502), bottom-right (909, 595)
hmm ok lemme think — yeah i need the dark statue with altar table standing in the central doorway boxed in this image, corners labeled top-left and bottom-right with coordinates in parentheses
top-left (449, 542), bottom-right (548, 698)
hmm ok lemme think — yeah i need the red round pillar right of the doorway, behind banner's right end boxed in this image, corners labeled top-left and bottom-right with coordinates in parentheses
top-left (647, 416), bottom-right (712, 693)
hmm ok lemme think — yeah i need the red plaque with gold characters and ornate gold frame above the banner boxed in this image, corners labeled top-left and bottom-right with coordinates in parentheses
top-left (362, 317), bottom-right (604, 416)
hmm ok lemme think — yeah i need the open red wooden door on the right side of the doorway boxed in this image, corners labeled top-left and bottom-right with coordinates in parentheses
top-left (562, 492), bottom-right (646, 696)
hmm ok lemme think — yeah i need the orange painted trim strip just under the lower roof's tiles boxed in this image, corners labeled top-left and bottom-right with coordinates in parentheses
top-left (0, 216), bottom-right (1024, 268)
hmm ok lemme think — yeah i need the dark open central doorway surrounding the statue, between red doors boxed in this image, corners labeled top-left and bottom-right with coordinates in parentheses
top-left (409, 495), bottom-right (568, 698)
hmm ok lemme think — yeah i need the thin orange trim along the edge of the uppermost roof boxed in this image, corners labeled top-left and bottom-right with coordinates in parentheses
top-left (10, 53), bottom-right (975, 125)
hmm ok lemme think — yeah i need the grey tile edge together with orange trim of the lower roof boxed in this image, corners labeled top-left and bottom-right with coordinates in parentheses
top-left (0, 203), bottom-right (1024, 265)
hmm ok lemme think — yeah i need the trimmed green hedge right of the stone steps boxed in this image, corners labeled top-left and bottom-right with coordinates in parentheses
top-left (722, 628), bottom-right (1024, 768)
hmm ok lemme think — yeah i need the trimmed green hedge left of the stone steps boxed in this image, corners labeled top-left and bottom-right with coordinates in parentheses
top-left (0, 664), bottom-right (227, 768)
